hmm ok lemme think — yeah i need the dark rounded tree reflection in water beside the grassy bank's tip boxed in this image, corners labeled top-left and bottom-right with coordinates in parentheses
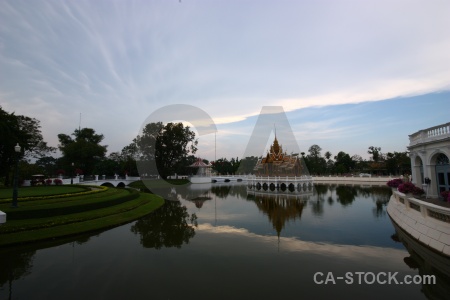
top-left (131, 201), bottom-right (197, 249)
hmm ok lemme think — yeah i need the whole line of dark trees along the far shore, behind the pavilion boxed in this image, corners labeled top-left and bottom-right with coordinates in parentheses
top-left (0, 107), bottom-right (411, 186)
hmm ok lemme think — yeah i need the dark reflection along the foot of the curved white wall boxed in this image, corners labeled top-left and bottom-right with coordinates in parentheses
top-left (392, 221), bottom-right (450, 299)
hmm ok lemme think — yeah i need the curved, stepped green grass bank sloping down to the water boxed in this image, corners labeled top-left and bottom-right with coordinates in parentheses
top-left (0, 188), bottom-right (164, 246)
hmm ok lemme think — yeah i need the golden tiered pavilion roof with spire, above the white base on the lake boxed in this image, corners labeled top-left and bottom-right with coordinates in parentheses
top-left (254, 135), bottom-right (309, 176)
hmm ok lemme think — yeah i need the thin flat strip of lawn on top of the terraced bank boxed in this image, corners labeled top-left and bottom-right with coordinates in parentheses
top-left (0, 185), bottom-right (87, 199)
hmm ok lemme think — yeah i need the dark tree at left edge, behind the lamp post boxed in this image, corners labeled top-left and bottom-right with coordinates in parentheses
top-left (0, 107), bottom-right (55, 186)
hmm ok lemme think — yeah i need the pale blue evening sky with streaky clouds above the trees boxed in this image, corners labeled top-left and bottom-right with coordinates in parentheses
top-left (0, 0), bottom-right (450, 160)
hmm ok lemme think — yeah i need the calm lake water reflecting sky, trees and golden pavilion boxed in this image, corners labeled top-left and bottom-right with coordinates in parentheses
top-left (0, 184), bottom-right (450, 299)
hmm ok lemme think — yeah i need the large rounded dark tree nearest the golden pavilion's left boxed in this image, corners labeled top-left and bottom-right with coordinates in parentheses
top-left (133, 122), bottom-right (198, 178)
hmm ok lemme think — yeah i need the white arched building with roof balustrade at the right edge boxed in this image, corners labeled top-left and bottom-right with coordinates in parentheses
top-left (408, 123), bottom-right (450, 197)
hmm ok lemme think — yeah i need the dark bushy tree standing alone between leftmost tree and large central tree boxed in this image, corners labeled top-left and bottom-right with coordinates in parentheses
top-left (58, 128), bottom-right (108, 175)
